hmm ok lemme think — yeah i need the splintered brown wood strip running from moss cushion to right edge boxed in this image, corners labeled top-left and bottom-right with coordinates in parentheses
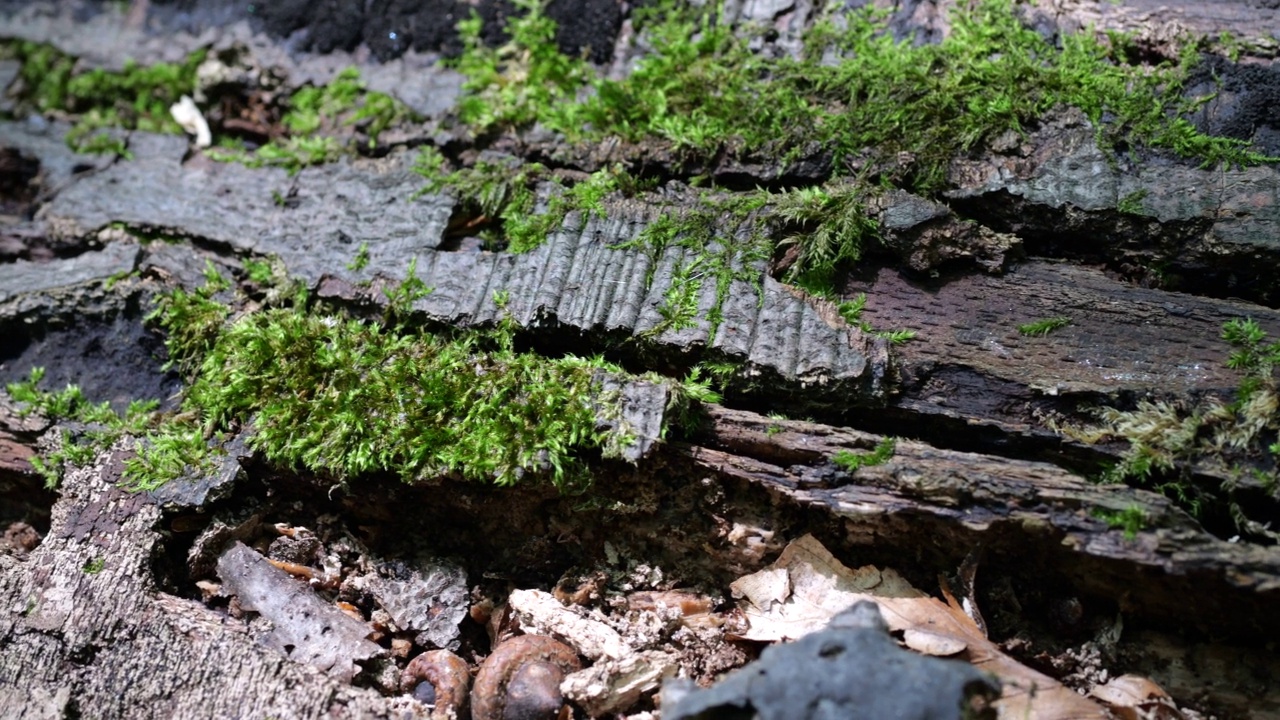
top-left (682, 407), bottom-right (1280, 638)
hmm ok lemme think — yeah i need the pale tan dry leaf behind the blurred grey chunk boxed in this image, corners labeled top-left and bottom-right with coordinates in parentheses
top-left (730, 536), bottom-right (1107, 720)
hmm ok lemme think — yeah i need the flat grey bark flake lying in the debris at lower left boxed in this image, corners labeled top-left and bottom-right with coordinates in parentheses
top-left (218, 542), bottom-right (383, 682)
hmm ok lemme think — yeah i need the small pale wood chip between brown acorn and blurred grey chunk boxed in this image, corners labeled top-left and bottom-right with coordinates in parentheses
top-left (561, 651), bottom-right (678, 717)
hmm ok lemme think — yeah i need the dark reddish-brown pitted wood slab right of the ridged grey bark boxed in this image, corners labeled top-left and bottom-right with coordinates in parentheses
top-left (849, 260), bottom-right (1280, 466)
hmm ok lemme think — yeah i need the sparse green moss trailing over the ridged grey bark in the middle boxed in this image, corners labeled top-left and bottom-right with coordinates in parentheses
top-left (415, 154), bottom-right (915, 343)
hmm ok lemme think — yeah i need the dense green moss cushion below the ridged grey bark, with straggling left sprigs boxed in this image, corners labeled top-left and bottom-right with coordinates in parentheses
top-left (125, 260), bottom-right (713, 491)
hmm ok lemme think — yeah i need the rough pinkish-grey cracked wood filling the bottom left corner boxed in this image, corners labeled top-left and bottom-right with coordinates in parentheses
top-left (0, 443), bottom-right (421, 717)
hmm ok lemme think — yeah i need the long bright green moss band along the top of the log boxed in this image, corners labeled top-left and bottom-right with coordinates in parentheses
top-left (448, 0), bottom-right (1268, 191)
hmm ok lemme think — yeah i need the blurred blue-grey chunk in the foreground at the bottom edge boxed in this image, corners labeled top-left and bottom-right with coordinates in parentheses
top-left (663, 601), bottom-right (1003, 720)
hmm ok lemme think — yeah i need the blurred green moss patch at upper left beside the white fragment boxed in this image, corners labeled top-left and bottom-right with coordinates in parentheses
top-left (0, 41), bottom-right (205, 155)
